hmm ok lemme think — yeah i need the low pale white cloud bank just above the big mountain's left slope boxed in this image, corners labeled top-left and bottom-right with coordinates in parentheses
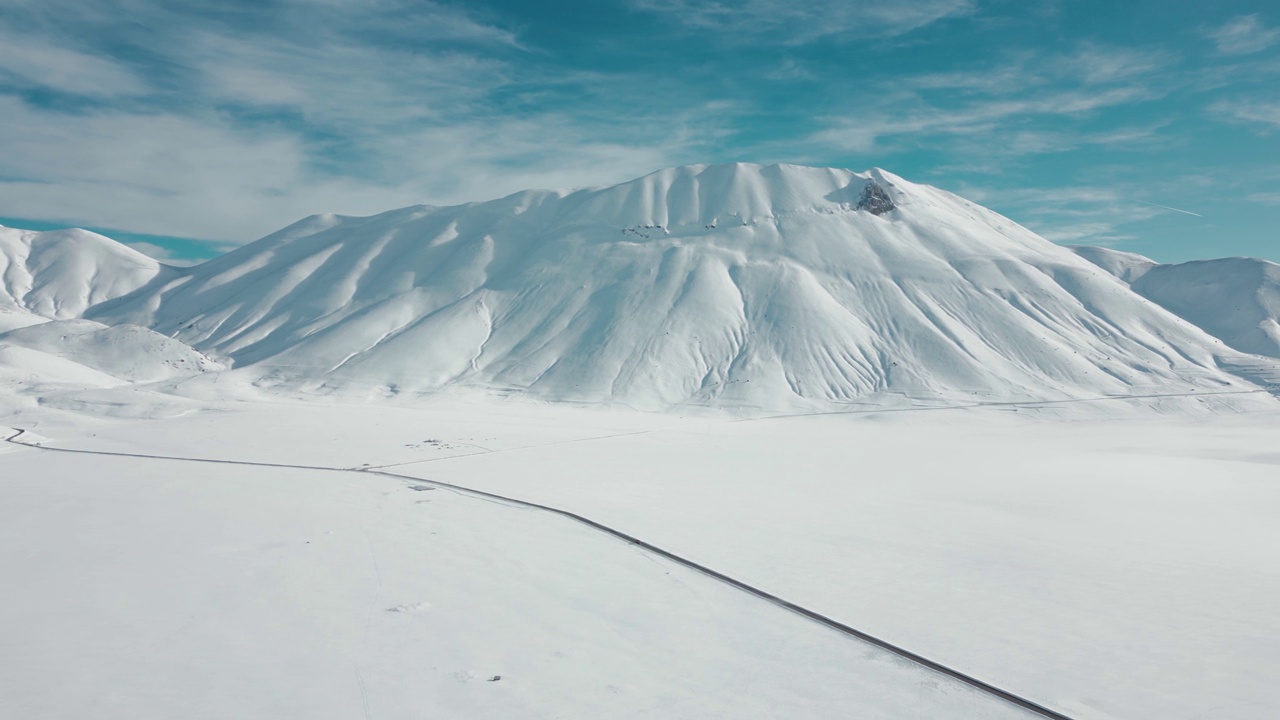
top-left (0, 92), bottom-right (709, 242)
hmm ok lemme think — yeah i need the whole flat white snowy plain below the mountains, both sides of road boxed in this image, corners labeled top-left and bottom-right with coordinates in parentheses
top-left (0, 388), bottom-right (1280, 720)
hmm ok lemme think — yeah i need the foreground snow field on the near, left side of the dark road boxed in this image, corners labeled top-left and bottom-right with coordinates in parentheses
top-left (0, 427), bottom-right (1025, 720)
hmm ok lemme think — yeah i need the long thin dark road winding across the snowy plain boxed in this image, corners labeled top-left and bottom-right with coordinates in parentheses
top-left (4, 428), bottom-right (1074, 720)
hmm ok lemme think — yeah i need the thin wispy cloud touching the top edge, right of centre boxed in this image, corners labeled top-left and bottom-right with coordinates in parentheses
top-left (631, 0), bottom-right (977, 45)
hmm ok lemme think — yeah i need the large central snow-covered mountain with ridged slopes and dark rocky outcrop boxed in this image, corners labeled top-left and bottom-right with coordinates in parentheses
top-left (90, 164), bottom-right (1269, 406)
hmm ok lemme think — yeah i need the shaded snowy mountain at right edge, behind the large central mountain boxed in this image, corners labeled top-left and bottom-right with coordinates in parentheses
top-left (1074, 247), bottom-right (1280, 357)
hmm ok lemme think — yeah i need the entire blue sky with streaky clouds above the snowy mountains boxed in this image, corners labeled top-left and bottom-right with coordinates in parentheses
top-left (0, 0), bottom-right (1280, 261)
